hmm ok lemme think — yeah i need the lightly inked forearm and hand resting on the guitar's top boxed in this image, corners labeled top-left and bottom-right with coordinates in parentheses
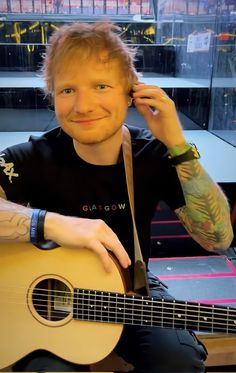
top-left (0, 187), bottom-right (131, 271)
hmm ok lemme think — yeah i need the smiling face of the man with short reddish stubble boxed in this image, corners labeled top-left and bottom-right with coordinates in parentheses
top-left (54, 57), bottom-right (130, 144)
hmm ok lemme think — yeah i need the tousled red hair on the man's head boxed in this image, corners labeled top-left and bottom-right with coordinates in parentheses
top-left (42, 21), bottom-right (138, 95)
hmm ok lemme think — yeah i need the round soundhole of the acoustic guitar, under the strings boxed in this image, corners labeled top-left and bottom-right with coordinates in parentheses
top-left (32, 278), bottom-right (73, 321)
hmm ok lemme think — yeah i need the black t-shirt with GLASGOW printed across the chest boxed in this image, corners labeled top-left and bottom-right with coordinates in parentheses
top-left (0, 126), bottom-right (185, 262)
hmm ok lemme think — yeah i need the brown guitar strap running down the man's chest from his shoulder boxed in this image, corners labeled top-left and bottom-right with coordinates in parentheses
top-left (122, 126), bottom-right (150, 295)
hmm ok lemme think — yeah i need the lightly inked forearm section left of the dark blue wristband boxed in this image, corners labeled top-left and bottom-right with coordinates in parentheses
top-left (0, 186), bottom-right (32, 242)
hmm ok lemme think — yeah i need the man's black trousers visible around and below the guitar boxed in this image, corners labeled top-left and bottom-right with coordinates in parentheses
top-left (13, 274), bottom-right (207, 373)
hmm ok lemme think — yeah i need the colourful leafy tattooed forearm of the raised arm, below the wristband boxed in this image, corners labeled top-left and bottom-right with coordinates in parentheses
top-left (176, 160), bottom-right (233, 250)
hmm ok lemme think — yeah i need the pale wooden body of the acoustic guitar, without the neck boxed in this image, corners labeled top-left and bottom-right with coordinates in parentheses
top-left (0, 244), bottom-right (126, 369)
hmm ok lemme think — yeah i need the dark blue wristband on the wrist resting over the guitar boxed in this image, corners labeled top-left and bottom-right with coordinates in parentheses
top-left (30, 209), bottom-right (58, 250)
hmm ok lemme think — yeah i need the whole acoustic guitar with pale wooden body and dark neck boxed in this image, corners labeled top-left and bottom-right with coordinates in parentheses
top-left (0, 244), bottom-right (236, 369)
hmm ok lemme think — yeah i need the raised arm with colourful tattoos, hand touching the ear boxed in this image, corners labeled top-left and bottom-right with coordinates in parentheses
top-left (133, 82), bottom-right (233, 250)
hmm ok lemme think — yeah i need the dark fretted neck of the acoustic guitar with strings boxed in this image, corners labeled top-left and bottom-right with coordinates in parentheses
top-left (73, 289), bottom-right (236, 334)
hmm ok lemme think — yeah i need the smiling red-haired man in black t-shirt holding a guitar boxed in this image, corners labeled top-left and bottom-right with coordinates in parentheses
top-left (0, 22), bottom-right (232, 373)
